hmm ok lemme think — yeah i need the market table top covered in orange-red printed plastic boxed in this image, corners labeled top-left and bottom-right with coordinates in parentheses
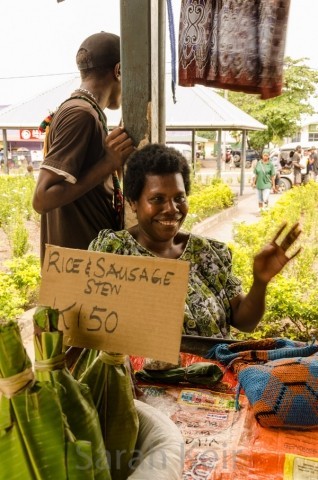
top-left (131, 346), bottom-right (318, 480)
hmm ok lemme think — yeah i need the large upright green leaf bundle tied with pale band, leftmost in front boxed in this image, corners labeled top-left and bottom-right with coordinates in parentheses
top-left (0, 322), bottom-right (94, 480)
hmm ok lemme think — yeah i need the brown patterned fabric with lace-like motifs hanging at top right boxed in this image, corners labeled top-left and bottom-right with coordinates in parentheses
top-left (179, 0), bottom-right (290, 99)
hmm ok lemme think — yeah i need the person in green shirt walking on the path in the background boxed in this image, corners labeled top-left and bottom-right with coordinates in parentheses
top-left (252, 151), bottom-right (276, 212)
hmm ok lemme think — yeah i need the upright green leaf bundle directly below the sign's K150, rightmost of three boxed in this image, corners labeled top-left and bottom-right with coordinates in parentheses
top-left (80, 352), bottom-right (139, 480)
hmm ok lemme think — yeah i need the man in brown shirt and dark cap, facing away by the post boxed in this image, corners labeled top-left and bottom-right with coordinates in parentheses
top-left (33, 32), bottom-right (133, 263)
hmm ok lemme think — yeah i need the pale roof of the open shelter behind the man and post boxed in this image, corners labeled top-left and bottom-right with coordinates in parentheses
top-left (0, 76), bottom-right (267, 130)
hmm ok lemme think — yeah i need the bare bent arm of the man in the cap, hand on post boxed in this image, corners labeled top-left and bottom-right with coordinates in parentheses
top-left (33, 128), bottom-right (133, 213)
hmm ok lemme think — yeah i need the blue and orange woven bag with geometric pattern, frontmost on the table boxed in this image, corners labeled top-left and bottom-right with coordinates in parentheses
top-left (238, 354), bottom-right (318, 430)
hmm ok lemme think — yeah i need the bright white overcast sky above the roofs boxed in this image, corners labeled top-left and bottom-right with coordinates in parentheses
top-left (0, 0), bottom-right (318, 105)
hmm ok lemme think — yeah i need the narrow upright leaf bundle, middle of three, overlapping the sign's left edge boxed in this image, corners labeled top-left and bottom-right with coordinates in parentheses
top-left (33, 306), bottom-right (111, 480)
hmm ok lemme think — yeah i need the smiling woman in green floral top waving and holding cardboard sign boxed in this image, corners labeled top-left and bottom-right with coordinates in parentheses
top-left (89, 144), bottom-right (300, 338)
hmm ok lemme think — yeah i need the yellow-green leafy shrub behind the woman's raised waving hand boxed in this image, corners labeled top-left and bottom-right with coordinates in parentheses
top-left (230, 182), bottom-right (318, 341)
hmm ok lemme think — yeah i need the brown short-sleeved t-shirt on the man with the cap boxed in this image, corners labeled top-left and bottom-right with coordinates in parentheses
top-left (41, 99), bottom-right (118, 261)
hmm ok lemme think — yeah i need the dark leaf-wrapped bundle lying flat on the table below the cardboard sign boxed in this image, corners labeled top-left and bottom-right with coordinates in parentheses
top-left (135, 362), bottom-right (223, 388)
